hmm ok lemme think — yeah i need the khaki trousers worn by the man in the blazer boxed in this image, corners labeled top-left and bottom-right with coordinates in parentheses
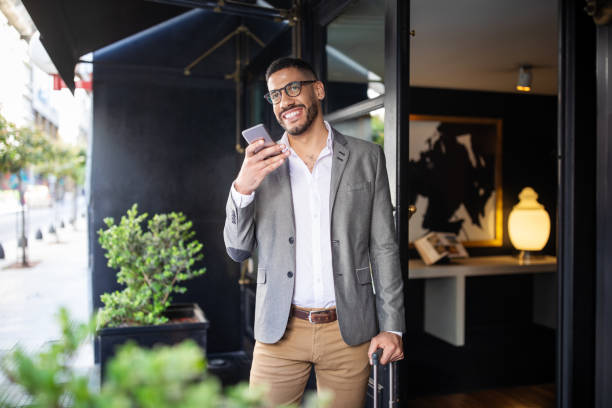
top-left (250, 309), bottom-right (370, 408)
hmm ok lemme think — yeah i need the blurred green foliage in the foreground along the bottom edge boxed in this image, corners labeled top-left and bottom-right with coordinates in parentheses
top-left (0, 309), bottom-right (329, 408)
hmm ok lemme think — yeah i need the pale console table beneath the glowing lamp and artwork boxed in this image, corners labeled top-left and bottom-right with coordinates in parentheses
top-left (408, 256), bottom-right (557, 346)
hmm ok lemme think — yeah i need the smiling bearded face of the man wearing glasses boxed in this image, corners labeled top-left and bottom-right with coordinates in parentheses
top-left (268, 67), bottom-right (325, 136)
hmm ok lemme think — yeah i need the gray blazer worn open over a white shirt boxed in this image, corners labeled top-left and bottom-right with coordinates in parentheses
top-left (223, 130), bottom-right (405, 345)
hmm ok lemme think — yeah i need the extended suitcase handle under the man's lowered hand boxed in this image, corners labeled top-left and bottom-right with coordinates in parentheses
top-left (365, 349), bottom-right (399, 408)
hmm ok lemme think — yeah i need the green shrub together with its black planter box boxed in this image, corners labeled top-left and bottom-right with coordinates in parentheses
top-left (97, 204), bottom-right (208, 376)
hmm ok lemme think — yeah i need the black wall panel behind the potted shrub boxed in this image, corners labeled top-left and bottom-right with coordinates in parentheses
top-left (90, 68), bottom-right (240, 351)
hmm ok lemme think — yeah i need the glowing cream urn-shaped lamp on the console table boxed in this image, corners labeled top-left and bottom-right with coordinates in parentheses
top-left (508, 187), bottom-right (550, 251)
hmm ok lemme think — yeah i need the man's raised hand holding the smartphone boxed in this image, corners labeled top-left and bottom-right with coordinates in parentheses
top-left (234, 139), bottom-right (291, 195)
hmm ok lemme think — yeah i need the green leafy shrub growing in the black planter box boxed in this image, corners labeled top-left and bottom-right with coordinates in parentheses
top-left (98, 204), bottom-right (205, 327)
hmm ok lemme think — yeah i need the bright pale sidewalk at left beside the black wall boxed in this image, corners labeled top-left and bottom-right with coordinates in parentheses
top-left (0, 217), bottom-right (93, 366)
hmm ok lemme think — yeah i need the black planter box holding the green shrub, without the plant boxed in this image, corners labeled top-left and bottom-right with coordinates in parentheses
top-left (96, 303), bottom-right (209, 380)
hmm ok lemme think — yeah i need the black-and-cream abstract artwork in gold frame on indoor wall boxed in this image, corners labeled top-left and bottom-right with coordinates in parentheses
top-left (408, 115), bottom-right (503, 247)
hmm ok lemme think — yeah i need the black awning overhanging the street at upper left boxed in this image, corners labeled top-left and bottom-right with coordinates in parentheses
top-left (23, 0), bottom-right (189, 91)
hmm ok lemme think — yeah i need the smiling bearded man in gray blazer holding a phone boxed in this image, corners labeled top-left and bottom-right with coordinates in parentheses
top-left (224, 58), bottom-right (404, 408)
